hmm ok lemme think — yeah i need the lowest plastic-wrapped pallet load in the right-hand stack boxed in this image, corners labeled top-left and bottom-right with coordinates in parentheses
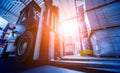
top-left (91, 27), bottom-right (120, 56)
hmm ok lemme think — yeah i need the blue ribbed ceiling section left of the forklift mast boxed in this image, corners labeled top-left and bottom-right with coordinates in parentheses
top-left (0, 0), bottom-right (43, 24)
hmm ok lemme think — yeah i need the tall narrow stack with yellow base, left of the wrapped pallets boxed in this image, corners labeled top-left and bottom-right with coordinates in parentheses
top-left (77, 5), bottom-right (93, 56)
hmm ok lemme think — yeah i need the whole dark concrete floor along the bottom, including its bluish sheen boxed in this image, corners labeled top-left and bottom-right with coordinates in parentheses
top-left (0, 58), bottom-right (120, 73)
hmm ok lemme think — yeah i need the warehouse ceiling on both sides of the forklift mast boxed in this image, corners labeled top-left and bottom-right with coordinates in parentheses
top-left (0, 0), bottom-right (83, 24)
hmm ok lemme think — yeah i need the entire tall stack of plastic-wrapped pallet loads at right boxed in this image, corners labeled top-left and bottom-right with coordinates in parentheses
top-left (85, 0), bottom-right (120, 56)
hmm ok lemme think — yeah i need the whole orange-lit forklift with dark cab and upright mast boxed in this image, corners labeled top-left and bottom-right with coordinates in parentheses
top-left (14, 0), bottom-right (60, 63)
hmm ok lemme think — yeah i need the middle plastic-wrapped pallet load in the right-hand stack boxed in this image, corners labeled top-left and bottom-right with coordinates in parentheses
top-left (86, 2), bottom-right (120, 33)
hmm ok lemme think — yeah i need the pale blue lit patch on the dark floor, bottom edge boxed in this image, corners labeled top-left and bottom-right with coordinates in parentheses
top-left (22, 65), bottom-right (85, 73)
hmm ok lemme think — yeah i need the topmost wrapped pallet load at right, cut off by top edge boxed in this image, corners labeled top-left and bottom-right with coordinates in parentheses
top-left (85, 0), bottom-right (116, 10)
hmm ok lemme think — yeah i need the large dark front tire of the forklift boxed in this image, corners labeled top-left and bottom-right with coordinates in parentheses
top-left (16, 31), bottom-right (34, 63)
